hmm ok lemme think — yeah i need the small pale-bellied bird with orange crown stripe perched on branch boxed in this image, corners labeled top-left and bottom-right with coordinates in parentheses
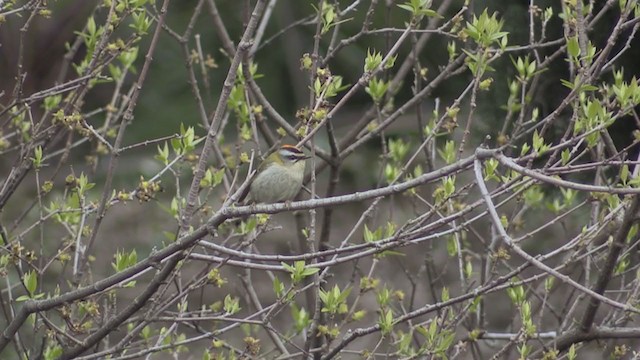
top-left (248, 145), bottom-right (309, 204)
